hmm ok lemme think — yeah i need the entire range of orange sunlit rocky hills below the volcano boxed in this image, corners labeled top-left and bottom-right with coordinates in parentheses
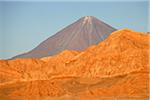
top-left (0, 29), bottom-right (150, 100)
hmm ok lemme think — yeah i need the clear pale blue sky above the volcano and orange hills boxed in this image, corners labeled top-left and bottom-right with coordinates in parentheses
top-left (0, 0), bottom-right (149, 59)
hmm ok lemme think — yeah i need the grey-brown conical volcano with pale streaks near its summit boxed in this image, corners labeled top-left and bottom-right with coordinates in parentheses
top-left (13, 16), bottom-right (116, 59)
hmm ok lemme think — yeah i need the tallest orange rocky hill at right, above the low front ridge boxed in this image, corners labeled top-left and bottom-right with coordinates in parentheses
top-left (60, 29), bottom-right (149, 77)
